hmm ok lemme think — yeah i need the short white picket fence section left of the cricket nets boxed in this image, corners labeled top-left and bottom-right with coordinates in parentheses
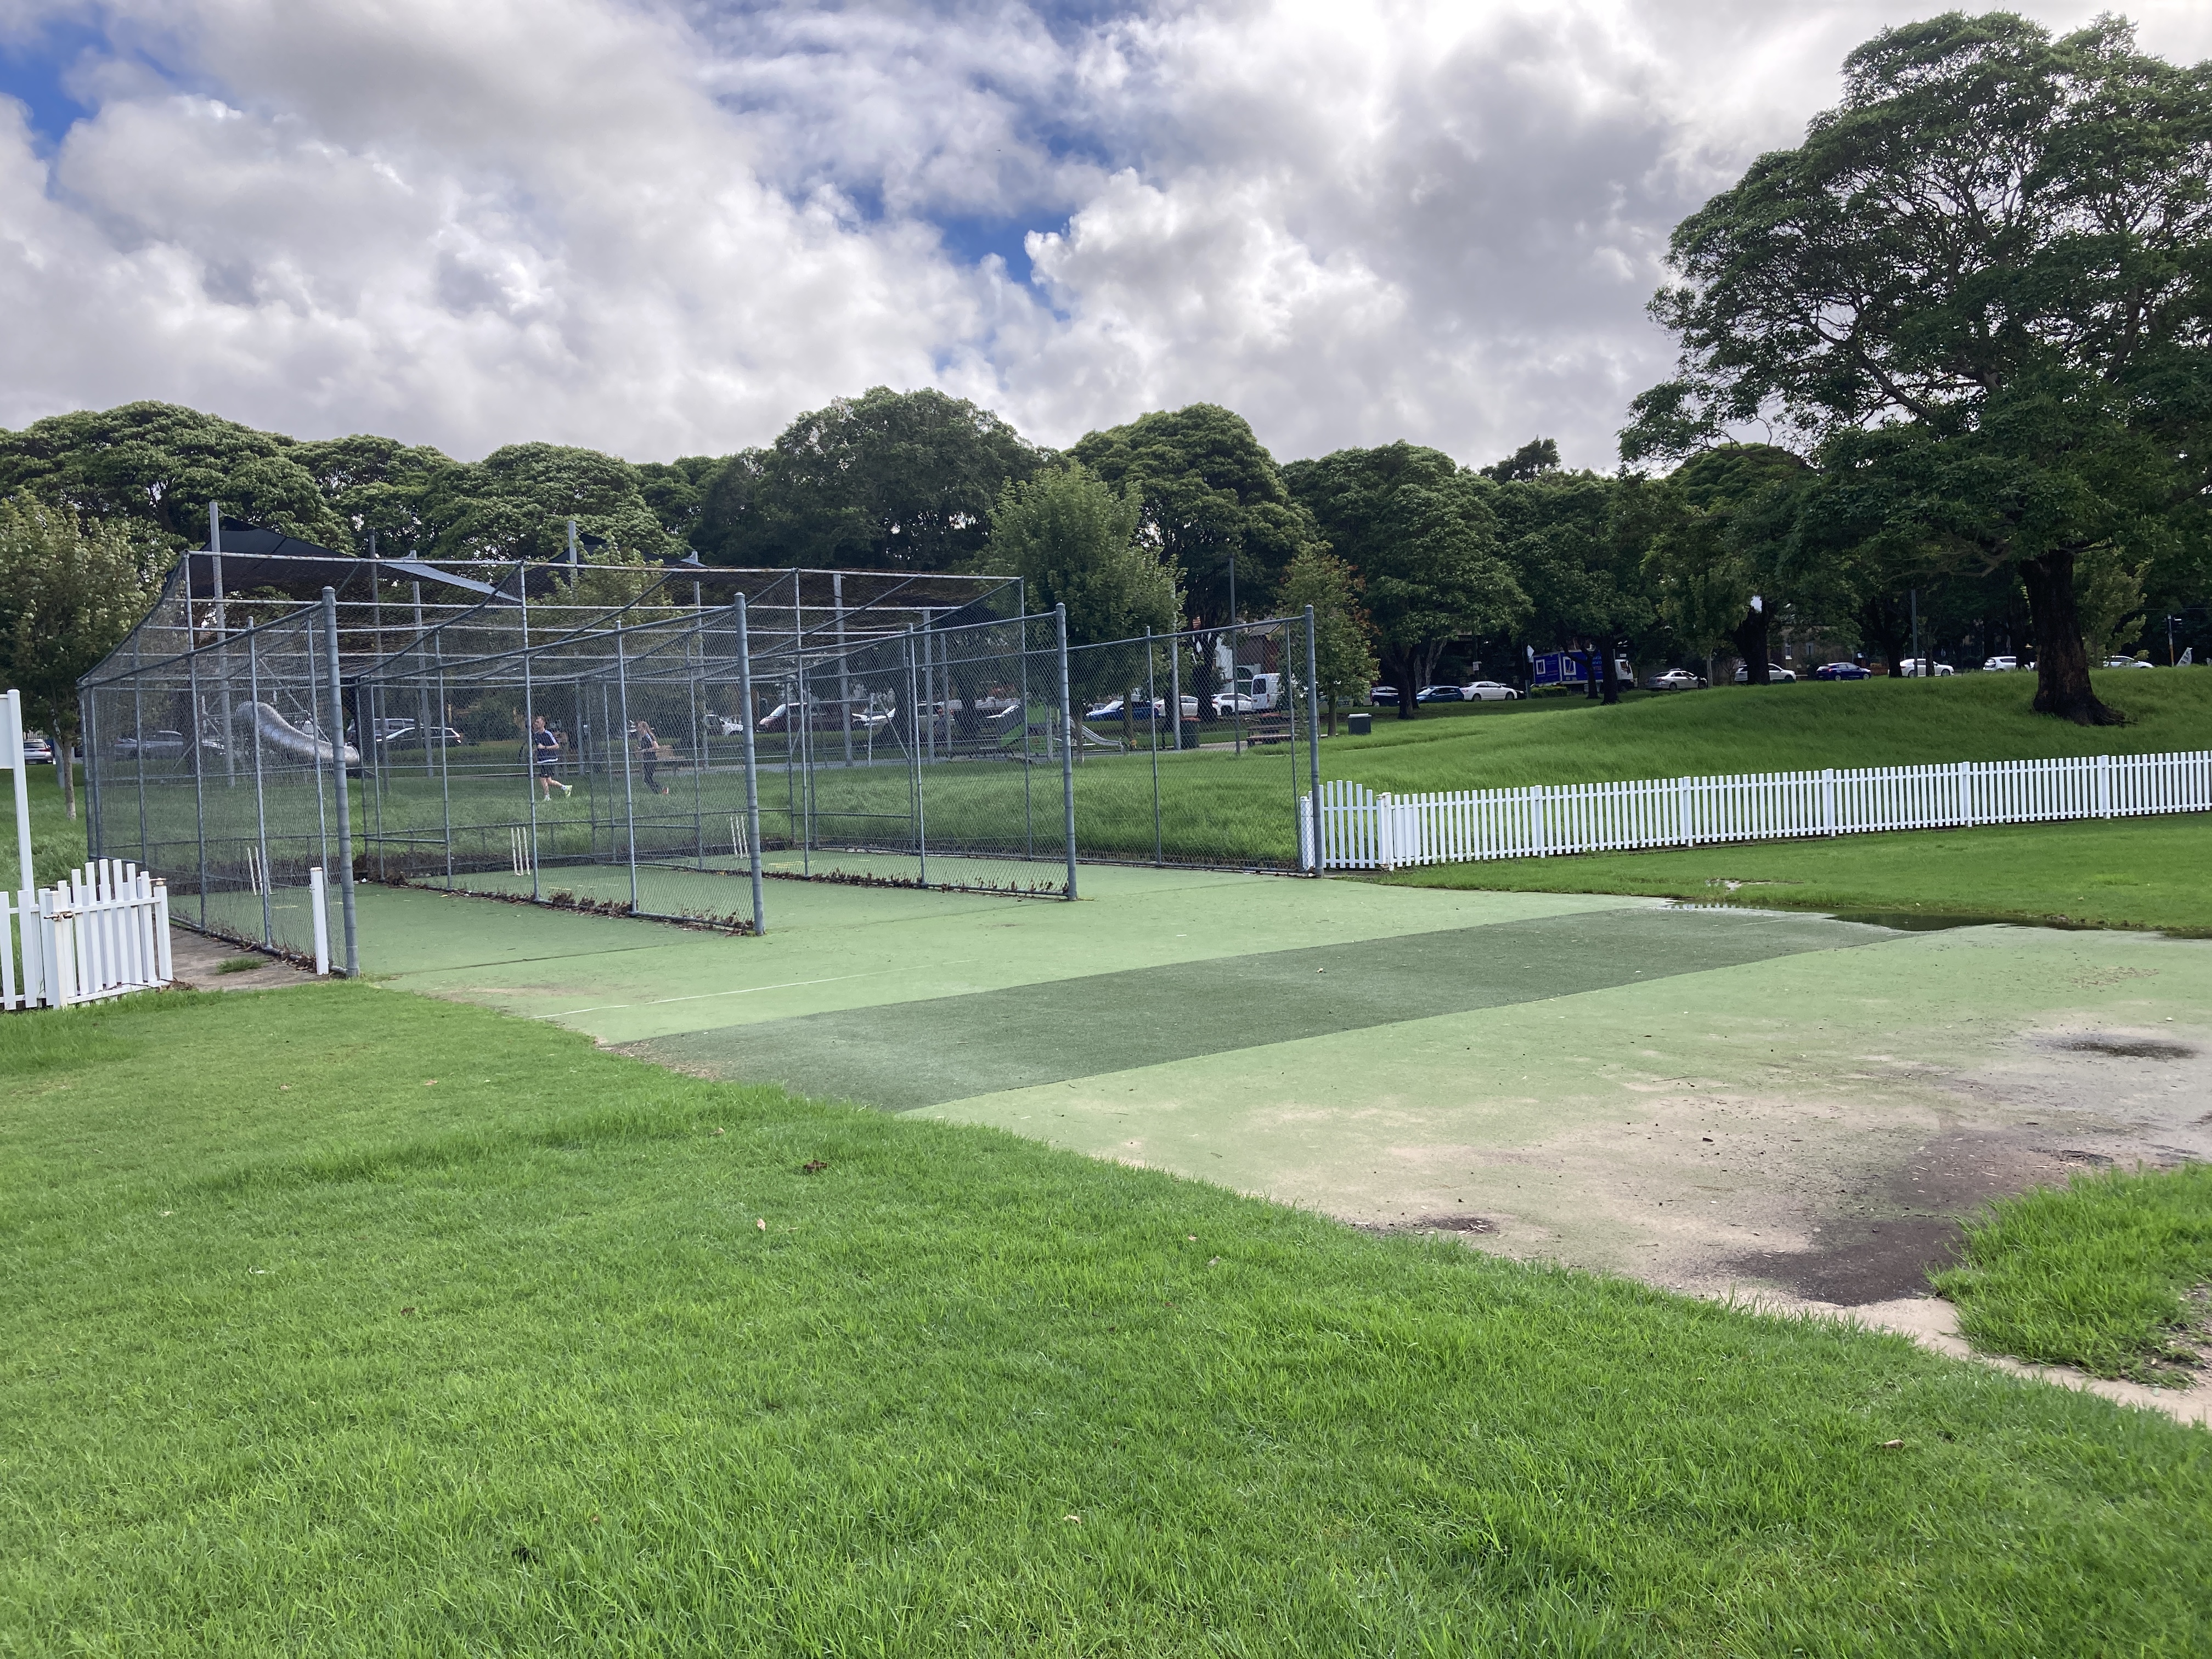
top-left (0, 858), bottom-right (170, 1009)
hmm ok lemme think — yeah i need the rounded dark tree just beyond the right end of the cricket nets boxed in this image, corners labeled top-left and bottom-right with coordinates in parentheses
top-left (1283, 442), bottom-right (1528, 719)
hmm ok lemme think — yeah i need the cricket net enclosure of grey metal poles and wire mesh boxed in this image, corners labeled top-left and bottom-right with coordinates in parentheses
top-left (84, 555), bottom-right (1312, 956)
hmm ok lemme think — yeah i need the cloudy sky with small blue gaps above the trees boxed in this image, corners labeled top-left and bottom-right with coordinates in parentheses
top-left (0, 0), bottom-right (2212, 467)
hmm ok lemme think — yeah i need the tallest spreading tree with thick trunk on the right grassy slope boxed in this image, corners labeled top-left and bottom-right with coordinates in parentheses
top-left (1621, 13), bottom-right (2212, 723)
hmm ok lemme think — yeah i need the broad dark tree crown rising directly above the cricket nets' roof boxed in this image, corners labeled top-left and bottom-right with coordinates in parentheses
top-left (692, 387), bottom-right (1044, 571)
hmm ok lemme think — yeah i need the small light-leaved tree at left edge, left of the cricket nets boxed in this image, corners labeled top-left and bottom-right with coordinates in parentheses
top-left (0, 495), bottom-right (170, 819)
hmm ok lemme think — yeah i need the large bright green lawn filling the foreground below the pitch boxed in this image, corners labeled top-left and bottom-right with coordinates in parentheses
top-left (0, 984), bottom-right (2212, 1655)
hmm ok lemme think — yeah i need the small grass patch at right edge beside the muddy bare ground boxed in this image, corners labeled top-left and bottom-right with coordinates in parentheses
top-left (1933, 1164), bottom-right (2212, 1383)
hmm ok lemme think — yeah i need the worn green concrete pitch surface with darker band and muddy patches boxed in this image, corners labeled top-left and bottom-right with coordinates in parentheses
top-left (363, 870), bottom-right (2212, 1353)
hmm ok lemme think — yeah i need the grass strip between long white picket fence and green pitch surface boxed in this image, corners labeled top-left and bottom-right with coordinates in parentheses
top-left (1376, 812), bottom-right (2212, 936)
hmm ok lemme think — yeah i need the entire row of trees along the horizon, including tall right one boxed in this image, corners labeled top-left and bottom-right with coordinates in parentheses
top-left (0, 13), bottom-right (2212, 721)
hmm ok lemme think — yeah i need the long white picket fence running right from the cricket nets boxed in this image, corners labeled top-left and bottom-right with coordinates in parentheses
top-left (1299, 750), bottom-right (2212, 870)
